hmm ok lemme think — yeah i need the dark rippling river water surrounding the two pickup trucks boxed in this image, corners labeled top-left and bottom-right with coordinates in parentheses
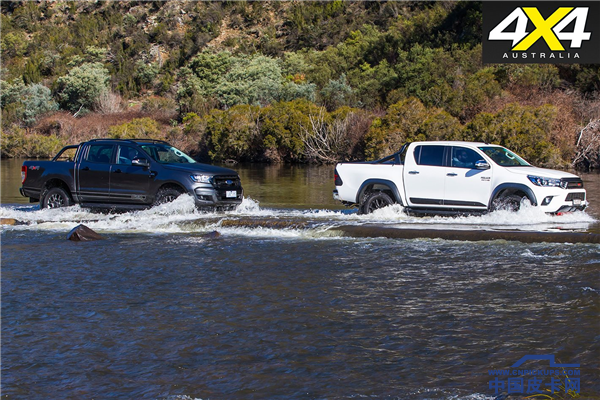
top-left (0, 160), bottom-right (600, 399)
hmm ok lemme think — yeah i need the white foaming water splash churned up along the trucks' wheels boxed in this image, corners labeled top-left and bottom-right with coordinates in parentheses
top-left (0, 196), bottom-right (596, 237)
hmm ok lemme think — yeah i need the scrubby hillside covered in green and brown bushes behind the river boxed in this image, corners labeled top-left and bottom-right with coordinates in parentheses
top-left (1, 1), bottom-right (600, 168)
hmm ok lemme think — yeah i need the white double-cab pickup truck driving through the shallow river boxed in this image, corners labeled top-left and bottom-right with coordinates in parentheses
top-left (333, 142), bottom-right (587, 214)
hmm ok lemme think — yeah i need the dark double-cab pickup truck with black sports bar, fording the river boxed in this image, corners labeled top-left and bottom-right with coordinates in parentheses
top-left (20, 139), bottom-right (243, 210)
